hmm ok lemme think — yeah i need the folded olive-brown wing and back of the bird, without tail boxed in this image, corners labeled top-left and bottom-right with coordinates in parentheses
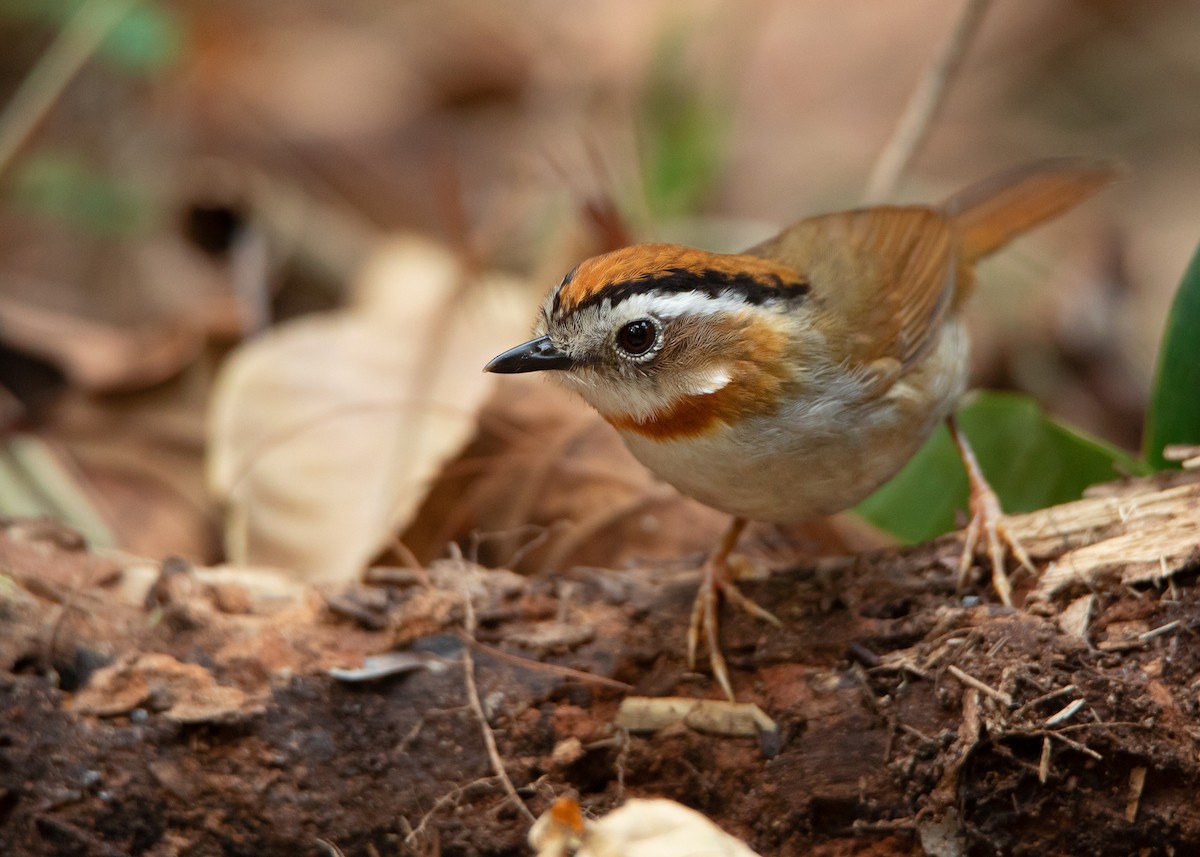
top-left (746, 205), bottom-right (970, 366)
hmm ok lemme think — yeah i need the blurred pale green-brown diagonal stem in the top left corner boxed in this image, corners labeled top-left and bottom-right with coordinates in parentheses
top-left (0, 0), bottom-right (140, 174)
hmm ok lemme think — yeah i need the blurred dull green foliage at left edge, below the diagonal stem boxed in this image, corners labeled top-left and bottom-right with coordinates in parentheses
top-left (5, 151), bottom-right (154, 238)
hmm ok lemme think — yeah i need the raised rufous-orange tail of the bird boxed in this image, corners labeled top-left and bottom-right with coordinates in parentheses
top-left (942, 157), bottom-right (1123, 262)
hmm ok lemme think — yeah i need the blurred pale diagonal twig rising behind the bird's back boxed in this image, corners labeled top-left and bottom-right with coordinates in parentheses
top-left (864, 0), bottom-right (989, 204)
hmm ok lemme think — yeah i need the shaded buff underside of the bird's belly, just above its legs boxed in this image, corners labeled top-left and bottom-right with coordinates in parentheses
top-left (622, 324), bottom-right (966, 523)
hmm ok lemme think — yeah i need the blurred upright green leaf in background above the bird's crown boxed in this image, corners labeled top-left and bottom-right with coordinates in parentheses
top-left (638, 28), bottom-right (728, 220)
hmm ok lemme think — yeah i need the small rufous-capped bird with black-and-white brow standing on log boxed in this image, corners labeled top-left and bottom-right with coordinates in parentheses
top-left (485, 157), bottom-right (1122, 701)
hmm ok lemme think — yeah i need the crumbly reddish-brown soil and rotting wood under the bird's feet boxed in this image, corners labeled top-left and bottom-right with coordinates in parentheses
top-left (0, 470), bottom-right (1200, 857)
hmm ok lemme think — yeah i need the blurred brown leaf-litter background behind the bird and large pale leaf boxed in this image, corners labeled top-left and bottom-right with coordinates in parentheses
top-left (0, 0), bottom-right (1200, 562)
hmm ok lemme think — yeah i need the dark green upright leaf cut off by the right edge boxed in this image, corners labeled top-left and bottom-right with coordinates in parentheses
top-left (1142, 238), bottom-right (1200, 468)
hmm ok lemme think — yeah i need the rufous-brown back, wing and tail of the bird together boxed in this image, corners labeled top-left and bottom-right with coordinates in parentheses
top-left (746, 158), bottom-right (1120, 364)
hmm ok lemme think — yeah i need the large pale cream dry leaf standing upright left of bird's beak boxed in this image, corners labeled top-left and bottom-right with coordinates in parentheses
top-left (208, 238), bottom-right (529, 582)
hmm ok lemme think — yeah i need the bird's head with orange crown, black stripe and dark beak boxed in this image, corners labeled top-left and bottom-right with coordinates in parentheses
top-left (486, 244), bottom-right (808, 439)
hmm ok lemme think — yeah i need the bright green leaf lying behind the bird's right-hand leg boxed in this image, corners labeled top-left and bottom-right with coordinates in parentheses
top-left (857, 392), bottom-right (1146, 543)
